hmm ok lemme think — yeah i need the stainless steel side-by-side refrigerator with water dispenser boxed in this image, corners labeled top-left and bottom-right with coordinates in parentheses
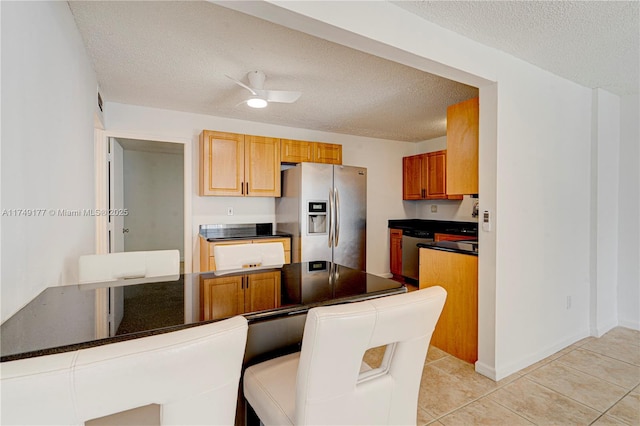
top-left (276, 163), bottom-right (367, 271)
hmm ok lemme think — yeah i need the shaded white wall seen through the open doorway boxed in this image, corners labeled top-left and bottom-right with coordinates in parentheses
top-left (124, 149), bottom-right (184, 260)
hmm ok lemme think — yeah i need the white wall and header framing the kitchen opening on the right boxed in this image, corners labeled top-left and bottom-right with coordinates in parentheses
top-left (248, 2), bottom-right (604, 379)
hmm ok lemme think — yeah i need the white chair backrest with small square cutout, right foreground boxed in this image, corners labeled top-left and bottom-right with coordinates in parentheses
top-left (294, 286), bottom-right (447, 425)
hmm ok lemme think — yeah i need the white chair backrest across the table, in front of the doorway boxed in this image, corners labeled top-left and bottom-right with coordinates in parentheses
top-left (78, 250), bottom-right (180, 284)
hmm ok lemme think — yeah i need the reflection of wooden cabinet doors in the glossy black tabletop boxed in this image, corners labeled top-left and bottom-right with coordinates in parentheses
top-left (200, 271), bottom-right (281, 321)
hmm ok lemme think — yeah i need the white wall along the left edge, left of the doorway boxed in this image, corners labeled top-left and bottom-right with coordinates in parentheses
top-left (1, 2), bottom-right (97, 322)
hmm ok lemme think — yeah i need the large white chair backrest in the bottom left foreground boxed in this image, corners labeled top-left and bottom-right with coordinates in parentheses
top-left (0, 316), bottom-right (247, 425)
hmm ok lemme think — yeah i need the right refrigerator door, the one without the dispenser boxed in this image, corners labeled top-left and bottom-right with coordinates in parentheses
top-left (333, 166), bottom-right (367, 271)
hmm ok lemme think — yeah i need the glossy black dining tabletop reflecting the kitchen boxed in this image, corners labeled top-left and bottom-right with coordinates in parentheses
top-left (0, 261), bottom-right (407, 362)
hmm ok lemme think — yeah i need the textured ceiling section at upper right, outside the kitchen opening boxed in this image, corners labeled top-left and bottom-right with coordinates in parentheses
top-left (393, 0), bottom-right (640, 95)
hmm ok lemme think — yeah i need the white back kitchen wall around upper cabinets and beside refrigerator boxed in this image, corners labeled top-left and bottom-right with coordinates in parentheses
top-left (105, 103), bottom-right (414, 275)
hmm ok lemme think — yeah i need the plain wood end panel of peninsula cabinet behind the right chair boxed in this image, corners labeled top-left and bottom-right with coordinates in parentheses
top-left (419, 249), bottom-right (478, 363)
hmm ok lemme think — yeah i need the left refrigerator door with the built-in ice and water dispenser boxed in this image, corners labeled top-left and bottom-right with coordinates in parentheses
top-left (296, 163), bottom-right (333, 262)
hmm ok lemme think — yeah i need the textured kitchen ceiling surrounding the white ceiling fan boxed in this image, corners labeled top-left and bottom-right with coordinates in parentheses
top-left (69, 1), bottom-right (477, 141)
